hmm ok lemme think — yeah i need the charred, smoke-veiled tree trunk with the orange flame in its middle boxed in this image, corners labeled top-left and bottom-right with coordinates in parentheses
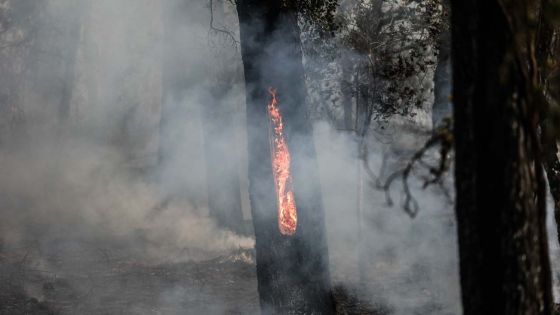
top-left (237, 0), bottom-right (334, 314)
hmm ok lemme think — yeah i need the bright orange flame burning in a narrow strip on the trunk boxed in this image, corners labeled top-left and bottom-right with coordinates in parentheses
top-left (268, 88), bottom-right (297, 235)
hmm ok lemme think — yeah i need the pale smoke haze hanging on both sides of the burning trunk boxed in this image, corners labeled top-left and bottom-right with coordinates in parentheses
top-left (0, 0), bottom-right (558, 315)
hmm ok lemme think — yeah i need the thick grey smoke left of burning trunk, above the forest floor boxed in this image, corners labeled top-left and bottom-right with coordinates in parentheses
top-left (0, 0), bottom-right (252, 261)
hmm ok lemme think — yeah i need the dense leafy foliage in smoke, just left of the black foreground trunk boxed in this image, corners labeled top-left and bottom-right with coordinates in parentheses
top-left (344, 0), bottom-right (446, 119)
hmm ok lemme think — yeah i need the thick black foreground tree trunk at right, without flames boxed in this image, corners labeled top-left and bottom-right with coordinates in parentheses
top-left (452, 0), bottom-right (553, 315)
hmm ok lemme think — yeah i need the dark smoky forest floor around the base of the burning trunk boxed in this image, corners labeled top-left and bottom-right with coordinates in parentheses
top-left (0, 249), bottom-right (386, 315)
